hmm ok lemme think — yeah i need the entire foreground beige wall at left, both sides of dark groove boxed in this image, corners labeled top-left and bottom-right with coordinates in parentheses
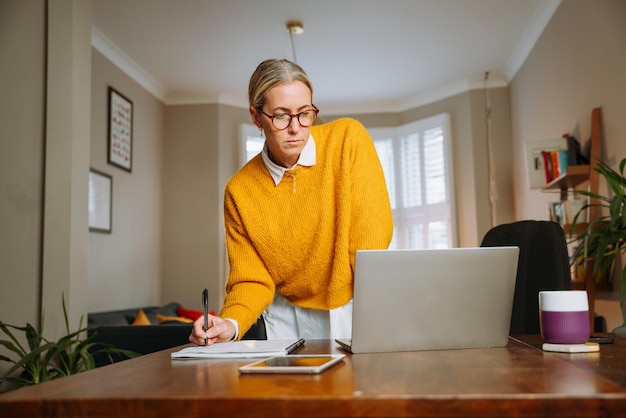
top-left (0, 0), bottom-right (91, 390)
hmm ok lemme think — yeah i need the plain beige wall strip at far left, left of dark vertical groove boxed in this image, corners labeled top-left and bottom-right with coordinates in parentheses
top-left (0, 0), bottom-right (46, 332)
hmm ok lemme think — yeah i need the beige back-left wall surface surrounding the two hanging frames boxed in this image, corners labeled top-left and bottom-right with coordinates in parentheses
top-left (87, 49), bottom-right (165, 312)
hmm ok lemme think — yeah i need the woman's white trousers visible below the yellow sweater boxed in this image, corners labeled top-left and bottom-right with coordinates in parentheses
top-left (263, 293), bottom-right (352, 340)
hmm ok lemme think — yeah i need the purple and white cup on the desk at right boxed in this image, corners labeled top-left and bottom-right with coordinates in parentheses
top-left (539, 290), bottom-right (590, 344)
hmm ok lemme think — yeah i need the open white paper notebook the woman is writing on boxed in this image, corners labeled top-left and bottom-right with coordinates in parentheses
top-left (172, 338), bottom-right (304, 359)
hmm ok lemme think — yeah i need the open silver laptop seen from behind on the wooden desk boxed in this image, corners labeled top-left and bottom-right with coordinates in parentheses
top-left (336, 247), bottom-right (519, 353)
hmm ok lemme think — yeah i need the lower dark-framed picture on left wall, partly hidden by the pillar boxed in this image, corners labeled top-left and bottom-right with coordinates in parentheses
top-left (89, 169), bottom-right (113, 234)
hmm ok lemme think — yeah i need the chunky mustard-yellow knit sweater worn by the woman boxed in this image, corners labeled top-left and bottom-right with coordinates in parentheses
top-left (221, 119), bottom-right (393, 336)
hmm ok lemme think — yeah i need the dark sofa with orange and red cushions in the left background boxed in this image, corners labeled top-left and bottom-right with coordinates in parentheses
top-left (87, 303), bottom-right (266, 367)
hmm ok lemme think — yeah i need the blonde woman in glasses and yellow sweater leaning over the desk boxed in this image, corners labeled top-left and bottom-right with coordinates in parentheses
top-left (189, 59), bottom-right (393, 345)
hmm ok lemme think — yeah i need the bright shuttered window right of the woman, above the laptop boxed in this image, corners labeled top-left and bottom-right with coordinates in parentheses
top-left (368, 114), bottom-right (456, 249)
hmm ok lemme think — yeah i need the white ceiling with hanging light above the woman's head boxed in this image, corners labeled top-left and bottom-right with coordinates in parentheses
top-left (92, 0), bottom-right (560, 113)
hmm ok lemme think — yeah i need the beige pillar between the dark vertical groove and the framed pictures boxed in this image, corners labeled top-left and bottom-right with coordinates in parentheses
top-left (41, 0), bottom-right (91, 336)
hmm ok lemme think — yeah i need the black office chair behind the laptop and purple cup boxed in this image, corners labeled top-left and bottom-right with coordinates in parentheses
top-left (480, 221), bottom-right (572, 334)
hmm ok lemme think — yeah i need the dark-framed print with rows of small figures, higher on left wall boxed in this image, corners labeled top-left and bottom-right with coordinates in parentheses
top-left (108, 87), bottom-right (133, 172)
